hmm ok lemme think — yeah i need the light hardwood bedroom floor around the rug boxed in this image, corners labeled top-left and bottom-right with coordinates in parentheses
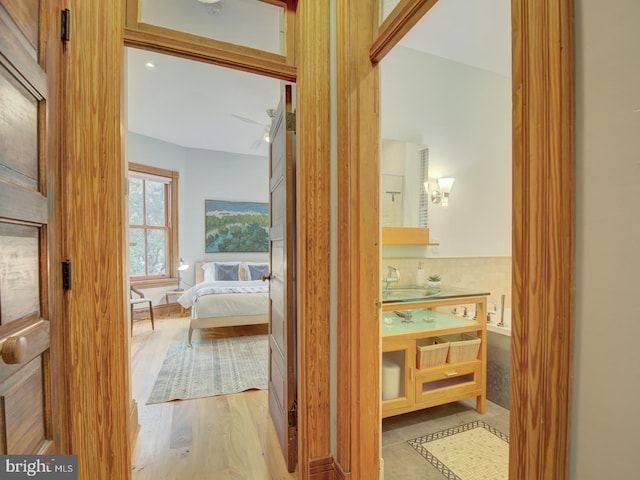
top-left (131, 317), bottom-right (297, 480)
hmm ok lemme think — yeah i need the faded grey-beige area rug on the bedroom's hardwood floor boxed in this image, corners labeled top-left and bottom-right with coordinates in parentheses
top-left (147, 335), bottom-right (269, 404)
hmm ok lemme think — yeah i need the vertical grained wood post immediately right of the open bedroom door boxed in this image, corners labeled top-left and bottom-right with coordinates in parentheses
top-left (296, 0), bottom-right (331, 479)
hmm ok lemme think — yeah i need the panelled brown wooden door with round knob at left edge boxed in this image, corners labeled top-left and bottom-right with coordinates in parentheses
top-left (0, 0), bottom-right (62, 454)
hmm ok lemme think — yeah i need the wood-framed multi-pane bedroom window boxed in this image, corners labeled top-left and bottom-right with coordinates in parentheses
top-left (129, 163), bottom-right (178, 285)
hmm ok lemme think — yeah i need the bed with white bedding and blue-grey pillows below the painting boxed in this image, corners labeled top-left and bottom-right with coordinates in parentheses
top-left (178, 262), bottom-right (269, 345)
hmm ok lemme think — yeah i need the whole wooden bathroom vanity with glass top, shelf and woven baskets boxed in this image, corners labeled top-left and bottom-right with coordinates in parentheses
top-left (380, 288), bottom-right (489, 417)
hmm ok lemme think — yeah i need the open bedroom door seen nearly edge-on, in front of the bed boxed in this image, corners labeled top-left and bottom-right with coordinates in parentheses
top-left (269, 85), bottom-right (297, 472)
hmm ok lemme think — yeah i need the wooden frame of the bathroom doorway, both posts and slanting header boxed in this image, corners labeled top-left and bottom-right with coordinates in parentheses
top-left (336, 0), bottom-right (575, 480)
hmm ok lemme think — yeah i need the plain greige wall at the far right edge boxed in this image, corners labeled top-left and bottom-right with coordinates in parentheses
top-left (570, 0), bottom-right (640, 480)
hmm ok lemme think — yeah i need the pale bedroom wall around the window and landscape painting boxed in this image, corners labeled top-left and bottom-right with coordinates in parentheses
top-left (127, 132), bottom-right (269, 296)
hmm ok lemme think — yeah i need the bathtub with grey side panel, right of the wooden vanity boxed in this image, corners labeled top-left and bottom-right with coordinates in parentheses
top-left (487, 308), bottom-right (511, 409)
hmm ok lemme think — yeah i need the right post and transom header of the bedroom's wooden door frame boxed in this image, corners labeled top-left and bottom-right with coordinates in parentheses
top-left (122, 0), bottom-right (334, 479)
